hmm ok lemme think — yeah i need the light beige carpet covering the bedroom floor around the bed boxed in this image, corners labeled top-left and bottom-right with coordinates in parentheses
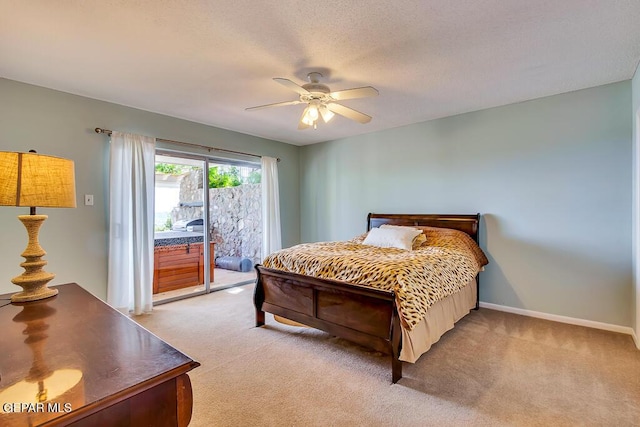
top-left (136, 285), bottom-right (640, 427)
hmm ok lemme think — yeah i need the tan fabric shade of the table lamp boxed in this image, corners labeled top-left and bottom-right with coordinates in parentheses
top-left (0, 151), bottom-right (76, 208)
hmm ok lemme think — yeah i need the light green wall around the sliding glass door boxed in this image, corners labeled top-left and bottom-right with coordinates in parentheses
top-left (0, 79), bottom-right (300, 298)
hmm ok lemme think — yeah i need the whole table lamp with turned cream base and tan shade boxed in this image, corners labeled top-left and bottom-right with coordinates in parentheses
top-left (0, 151), bottom-right (76, 302)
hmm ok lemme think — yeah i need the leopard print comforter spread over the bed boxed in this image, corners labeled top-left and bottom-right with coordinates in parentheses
top-left (263, 227), bottom-right (488, 330)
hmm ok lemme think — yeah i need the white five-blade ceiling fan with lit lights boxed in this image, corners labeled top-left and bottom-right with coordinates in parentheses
top-left (245, 72), bottom-right (378, 129)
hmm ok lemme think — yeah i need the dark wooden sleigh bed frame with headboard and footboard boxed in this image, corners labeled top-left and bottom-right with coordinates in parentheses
top-left (254, 213), bottom-right (480, 383)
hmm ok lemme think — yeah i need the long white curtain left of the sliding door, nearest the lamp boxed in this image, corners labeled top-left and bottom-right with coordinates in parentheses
top-left (107, 132), bottom-right (155, 314)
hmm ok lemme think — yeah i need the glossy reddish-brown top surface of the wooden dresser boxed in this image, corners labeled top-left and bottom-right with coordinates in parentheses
top-left (0, 283), bottom-right (199, 425)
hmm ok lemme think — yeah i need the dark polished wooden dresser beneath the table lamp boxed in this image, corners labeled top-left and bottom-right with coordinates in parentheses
top-left (0, 283), bottom-right (200, 427)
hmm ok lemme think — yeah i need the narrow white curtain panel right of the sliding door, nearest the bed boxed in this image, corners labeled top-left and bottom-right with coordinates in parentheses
top-left (261, 157), bottom-right (282, 258)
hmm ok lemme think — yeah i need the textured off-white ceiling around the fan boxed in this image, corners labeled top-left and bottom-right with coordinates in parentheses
top-left (0, 0), bottom-right (640, 145)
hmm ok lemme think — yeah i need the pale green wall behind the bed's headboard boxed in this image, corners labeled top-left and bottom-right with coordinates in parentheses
top-left (300, 81), bottom-right (633, 326)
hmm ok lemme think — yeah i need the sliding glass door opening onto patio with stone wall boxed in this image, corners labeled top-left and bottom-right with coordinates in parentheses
top-left (153, 150), bottom-right (262, 304)
